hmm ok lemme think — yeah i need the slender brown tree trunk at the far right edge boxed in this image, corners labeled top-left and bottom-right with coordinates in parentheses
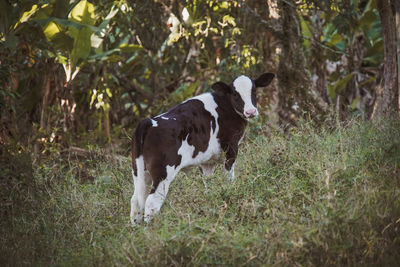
top-left (372, 0), bottom-right (398, 118)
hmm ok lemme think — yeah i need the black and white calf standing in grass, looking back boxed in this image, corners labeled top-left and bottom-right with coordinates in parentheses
top-left (130, 73), bottom-right (274, 224)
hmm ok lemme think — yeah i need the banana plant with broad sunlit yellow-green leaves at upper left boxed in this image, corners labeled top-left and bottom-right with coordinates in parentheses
top-left (15, 0), bottom-right (119, 83)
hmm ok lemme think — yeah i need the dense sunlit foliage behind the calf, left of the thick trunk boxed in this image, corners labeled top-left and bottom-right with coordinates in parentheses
top-left (0, 0), bottom-right (278, 149)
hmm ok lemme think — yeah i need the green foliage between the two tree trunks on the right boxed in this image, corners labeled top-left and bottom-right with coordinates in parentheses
top-left (299, 0), bottom-right (383, 116)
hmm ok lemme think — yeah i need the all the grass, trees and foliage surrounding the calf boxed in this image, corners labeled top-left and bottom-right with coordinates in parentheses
top-left (0, 0), bottom-right (400, 265)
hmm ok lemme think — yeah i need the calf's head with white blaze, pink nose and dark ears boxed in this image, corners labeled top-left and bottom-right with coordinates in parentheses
top-left (211, 73), bottom-right (275, 119)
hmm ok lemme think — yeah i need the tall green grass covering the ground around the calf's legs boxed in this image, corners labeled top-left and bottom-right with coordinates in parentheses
top-left (0, 120), bottom-right (400, 266)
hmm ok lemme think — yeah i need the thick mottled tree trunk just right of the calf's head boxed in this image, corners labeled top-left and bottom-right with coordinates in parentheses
top-left (277, 0), bottom-right (323, 124)
